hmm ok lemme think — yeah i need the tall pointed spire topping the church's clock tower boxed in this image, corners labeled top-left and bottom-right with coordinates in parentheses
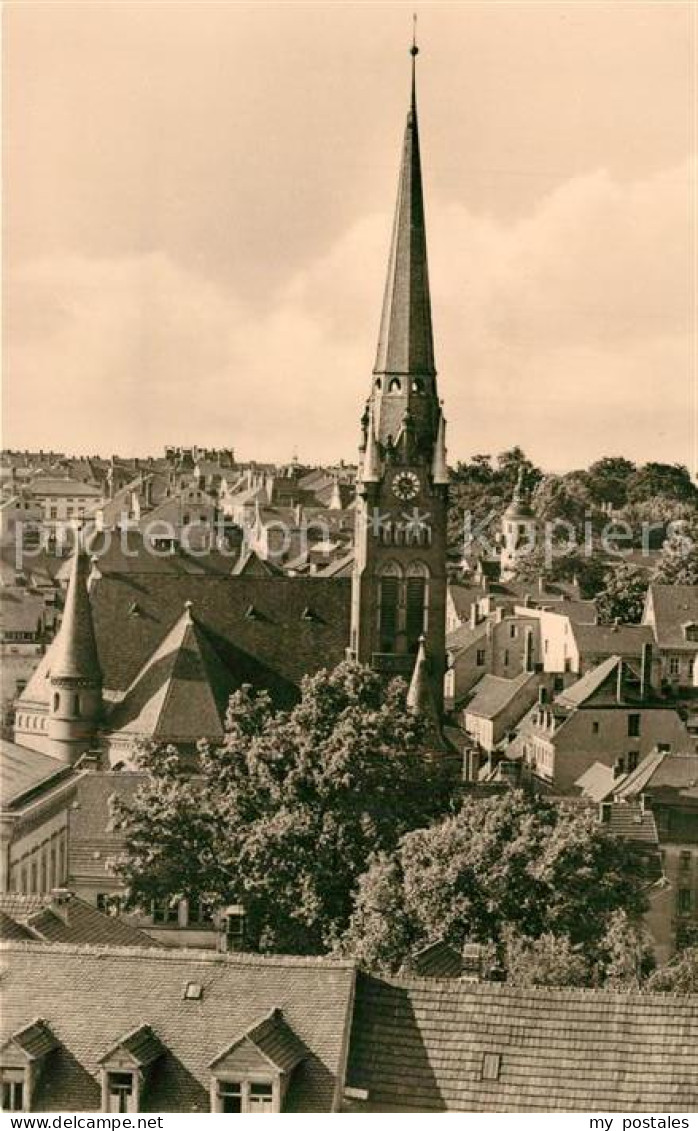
top-left (373, 30), bottom-right (436, 377)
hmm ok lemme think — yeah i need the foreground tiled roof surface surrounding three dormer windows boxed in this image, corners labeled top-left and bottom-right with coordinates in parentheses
top-left (0, 943), bottom-right (354, 1112)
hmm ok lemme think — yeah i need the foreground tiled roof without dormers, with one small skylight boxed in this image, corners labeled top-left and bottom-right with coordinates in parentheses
top-left (347, 976), bottom-right (698, 1112)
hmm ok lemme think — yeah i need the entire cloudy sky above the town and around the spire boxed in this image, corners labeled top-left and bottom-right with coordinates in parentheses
top-left (2, 0), bottom-right (698, 470)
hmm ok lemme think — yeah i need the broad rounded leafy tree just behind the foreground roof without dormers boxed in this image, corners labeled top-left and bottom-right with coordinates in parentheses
top-left (342, 792), bottom-right (644, 970)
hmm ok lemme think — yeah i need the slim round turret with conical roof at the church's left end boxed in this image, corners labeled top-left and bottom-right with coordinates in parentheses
top-left (49, 535), bottom-right (102, 765)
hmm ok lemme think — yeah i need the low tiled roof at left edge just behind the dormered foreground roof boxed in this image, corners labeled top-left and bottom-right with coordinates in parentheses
top-left (0, 893), bottom-right (157, 947)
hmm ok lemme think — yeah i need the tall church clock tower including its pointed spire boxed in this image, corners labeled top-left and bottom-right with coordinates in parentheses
top-left (350, 45), bottom-right (448, 711)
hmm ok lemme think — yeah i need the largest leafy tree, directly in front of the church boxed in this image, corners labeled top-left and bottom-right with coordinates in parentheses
top-left (119, 663), bottom-right (447, 953)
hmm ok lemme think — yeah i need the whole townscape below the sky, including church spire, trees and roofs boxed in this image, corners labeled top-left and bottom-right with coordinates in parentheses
top-left (0, 41), bottom-right (698, 1113)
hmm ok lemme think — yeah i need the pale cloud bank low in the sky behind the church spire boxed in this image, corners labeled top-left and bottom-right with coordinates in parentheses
top-left (5, 165), bottom-right (695, 467)
